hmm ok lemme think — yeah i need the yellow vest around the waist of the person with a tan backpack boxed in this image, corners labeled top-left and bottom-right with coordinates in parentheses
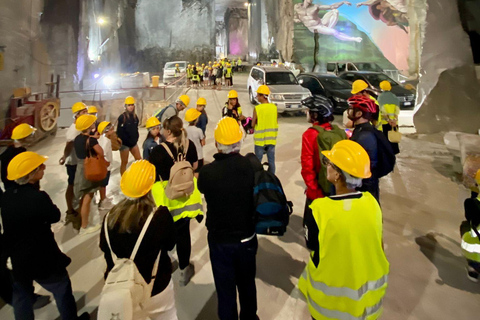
top-left (152, 178), bottom-right (203, 222)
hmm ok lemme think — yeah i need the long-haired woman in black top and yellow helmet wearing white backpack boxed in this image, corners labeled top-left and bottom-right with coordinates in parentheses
top-left (99, 160), bottom-right (177, 320)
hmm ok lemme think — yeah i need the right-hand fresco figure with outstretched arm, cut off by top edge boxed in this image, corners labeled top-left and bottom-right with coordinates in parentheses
top-left (357, 0), bottom-right (408, 32)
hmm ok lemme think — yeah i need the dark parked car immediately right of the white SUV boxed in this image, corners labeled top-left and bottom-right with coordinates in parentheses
top-left (297, 73), bottom-right (352, 114)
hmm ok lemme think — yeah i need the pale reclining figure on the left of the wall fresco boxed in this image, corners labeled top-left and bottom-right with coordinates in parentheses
top-left (293, 0), bottom-right (362, 42)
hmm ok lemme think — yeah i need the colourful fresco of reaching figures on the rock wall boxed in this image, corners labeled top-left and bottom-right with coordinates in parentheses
top-left (293, 0), bottom-right (410, 71)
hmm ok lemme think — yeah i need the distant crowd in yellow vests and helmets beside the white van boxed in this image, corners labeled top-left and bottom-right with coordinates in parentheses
top-left (186, 58), bottom-right (242, 90)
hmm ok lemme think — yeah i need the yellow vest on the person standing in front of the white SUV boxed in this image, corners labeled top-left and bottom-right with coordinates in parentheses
top-left (253, 103), bottom-right (278, 146)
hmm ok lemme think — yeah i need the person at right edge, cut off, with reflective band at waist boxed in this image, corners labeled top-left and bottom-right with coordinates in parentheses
top-left (460, 170), bottom-right (480, 282)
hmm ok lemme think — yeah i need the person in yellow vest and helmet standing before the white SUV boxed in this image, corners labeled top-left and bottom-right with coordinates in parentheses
top-left (252, 85), bottom-right (278, 174)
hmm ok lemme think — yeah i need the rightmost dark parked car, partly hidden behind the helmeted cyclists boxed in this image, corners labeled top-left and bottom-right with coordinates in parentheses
top-left (340, 71), bottom-right (415, 109)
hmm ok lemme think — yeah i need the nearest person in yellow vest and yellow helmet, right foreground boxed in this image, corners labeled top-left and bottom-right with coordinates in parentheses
top-left (298, 140), bottom-right (389, 320)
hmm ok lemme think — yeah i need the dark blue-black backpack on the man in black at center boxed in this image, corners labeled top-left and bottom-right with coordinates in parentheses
top-left (246, 153), bottom-right (293, 236)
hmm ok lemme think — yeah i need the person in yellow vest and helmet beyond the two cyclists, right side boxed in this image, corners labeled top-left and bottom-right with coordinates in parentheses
top-left (378, 80), bottom-right (400, 154)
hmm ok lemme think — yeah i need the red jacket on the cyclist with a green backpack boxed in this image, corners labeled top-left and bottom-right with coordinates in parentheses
top-left (300, 122), bottom-right (332, 200)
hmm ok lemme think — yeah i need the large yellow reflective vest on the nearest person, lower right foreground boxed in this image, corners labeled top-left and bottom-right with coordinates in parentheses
top-left (298, 192), bottom-right (389, 320)
